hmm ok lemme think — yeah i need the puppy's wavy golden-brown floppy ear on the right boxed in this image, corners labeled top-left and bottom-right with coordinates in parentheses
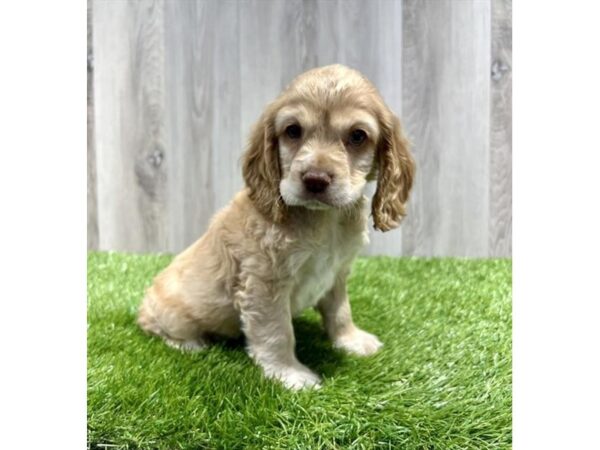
top-left (371, 111), bottom-right (415, 231)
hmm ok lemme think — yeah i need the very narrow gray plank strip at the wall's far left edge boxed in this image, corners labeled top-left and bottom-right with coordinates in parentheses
top-left (87, 0), bottom-right (99, 250)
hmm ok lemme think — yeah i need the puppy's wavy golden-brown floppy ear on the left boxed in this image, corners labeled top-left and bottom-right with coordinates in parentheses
top-left (242, 105), bottom-right (285, 223)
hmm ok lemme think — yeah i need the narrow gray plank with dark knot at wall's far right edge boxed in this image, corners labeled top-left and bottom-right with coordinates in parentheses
top-left (489, 0), bottom-right (512, 257)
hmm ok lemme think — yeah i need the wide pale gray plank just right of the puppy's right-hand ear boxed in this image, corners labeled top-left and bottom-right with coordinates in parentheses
top-left (402, 0), bottom-right (491, 257)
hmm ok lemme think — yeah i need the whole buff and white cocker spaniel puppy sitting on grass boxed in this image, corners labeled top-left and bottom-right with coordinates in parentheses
top-left (139, 65), bottom-right (414, 389)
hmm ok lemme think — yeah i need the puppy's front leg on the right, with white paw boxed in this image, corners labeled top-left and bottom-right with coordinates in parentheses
top-left (317, 270), bottom-right (383, 356)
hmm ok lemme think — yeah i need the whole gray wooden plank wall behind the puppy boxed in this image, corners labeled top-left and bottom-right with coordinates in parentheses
top-left (88, 0), bottom-right (512, 257)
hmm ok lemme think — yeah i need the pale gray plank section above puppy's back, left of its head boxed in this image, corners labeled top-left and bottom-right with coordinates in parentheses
top-left (165, 1), bottom-right (242, 252)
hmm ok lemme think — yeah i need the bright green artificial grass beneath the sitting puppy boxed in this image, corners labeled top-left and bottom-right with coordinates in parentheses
top-left (88, 253), bottom-right (512, 449)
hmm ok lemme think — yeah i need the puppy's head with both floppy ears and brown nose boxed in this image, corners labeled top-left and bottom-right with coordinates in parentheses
top-left (243, 65), bottom-right (414, 231)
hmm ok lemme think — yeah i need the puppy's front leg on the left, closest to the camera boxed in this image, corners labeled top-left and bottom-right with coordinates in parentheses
top-left (239, 280), bottom-right (320, 389)
